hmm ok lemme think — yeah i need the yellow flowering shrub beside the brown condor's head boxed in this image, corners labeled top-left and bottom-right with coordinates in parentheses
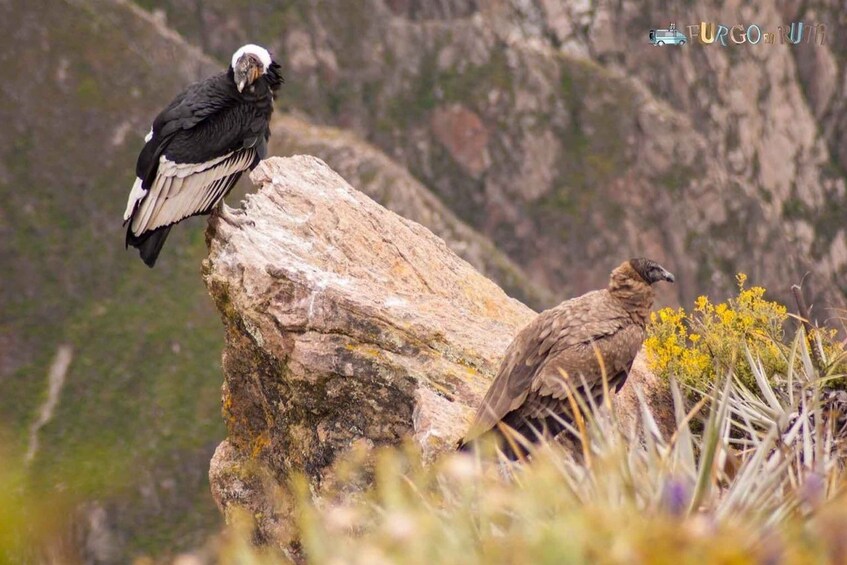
top-left (646, 273), bottom-right (788, 391)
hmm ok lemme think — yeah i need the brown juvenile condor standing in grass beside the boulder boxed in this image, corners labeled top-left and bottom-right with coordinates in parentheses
top-left (459, 258), bottom-right (674, 460)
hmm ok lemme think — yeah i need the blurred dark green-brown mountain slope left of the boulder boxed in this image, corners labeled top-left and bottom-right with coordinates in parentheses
top-left (0, 0), bottom-right (223, 561)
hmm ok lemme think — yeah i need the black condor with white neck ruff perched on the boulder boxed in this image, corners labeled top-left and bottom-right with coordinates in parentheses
top-left (124, 45), bottom-right (283, 267)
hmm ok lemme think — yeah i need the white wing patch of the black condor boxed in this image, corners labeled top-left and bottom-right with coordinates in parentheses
top-left (128, 149), bottom-right (256, 235)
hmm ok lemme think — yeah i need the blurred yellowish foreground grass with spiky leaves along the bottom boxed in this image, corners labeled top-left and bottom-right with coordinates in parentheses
top-left (6, 289), bottom-right (847, 564)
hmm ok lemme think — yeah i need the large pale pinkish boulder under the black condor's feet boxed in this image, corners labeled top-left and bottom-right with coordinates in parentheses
top-left (204, 156), bottom-right (668, 541)
